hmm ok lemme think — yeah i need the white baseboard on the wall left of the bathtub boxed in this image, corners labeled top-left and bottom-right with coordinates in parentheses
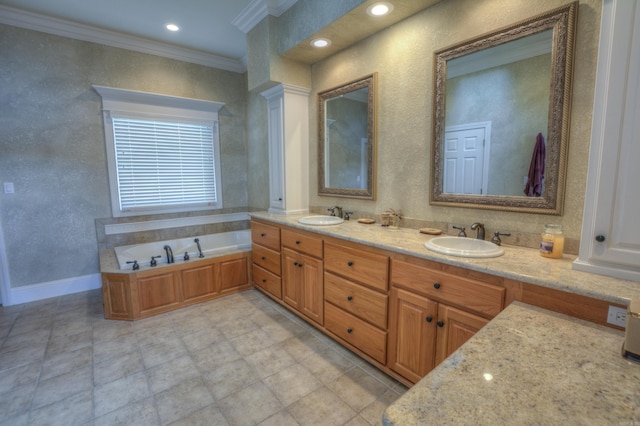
top-left (5, 274), bottom-right (102, 306)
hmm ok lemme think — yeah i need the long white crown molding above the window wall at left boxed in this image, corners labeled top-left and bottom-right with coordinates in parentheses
top-left (0, 5), bottom-right (246, 73)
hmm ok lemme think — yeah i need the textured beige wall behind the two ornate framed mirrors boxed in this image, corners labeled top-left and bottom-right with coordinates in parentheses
top-left (310, 0), bottom-right (601, 245)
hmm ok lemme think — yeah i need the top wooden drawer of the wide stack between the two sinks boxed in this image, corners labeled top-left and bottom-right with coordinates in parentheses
top-left (324, 243), bottom-right (389, 291)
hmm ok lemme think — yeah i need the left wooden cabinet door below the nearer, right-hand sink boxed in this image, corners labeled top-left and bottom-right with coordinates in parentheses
top-left (388, 287), bottom-right (438, 383)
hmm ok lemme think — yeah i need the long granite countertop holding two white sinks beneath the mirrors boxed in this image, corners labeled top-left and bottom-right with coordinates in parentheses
top-left (251, 212), bottom-right (640, 306)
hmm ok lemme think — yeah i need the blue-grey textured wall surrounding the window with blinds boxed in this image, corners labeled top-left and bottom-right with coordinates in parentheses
top-left (0, 25), bottom-right (248, 300)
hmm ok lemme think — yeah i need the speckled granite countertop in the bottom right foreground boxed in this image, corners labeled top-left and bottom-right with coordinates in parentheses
top-left (383, 302), bottom-right (640, 425)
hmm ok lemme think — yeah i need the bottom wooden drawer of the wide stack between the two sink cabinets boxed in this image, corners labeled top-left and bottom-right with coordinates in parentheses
top-left (324, 302), bottom-right (387, 364)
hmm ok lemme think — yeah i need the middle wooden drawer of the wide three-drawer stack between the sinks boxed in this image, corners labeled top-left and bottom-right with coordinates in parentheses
top-left (324, 272), bottom-right (387, 330)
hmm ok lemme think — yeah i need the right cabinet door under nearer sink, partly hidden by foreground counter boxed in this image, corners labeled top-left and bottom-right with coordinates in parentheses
top-left (435, 304), bottom-right (489, 365)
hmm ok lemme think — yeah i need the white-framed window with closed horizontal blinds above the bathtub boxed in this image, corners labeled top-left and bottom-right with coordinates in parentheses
top-left (94, 86), bottom-right (222, 217)
